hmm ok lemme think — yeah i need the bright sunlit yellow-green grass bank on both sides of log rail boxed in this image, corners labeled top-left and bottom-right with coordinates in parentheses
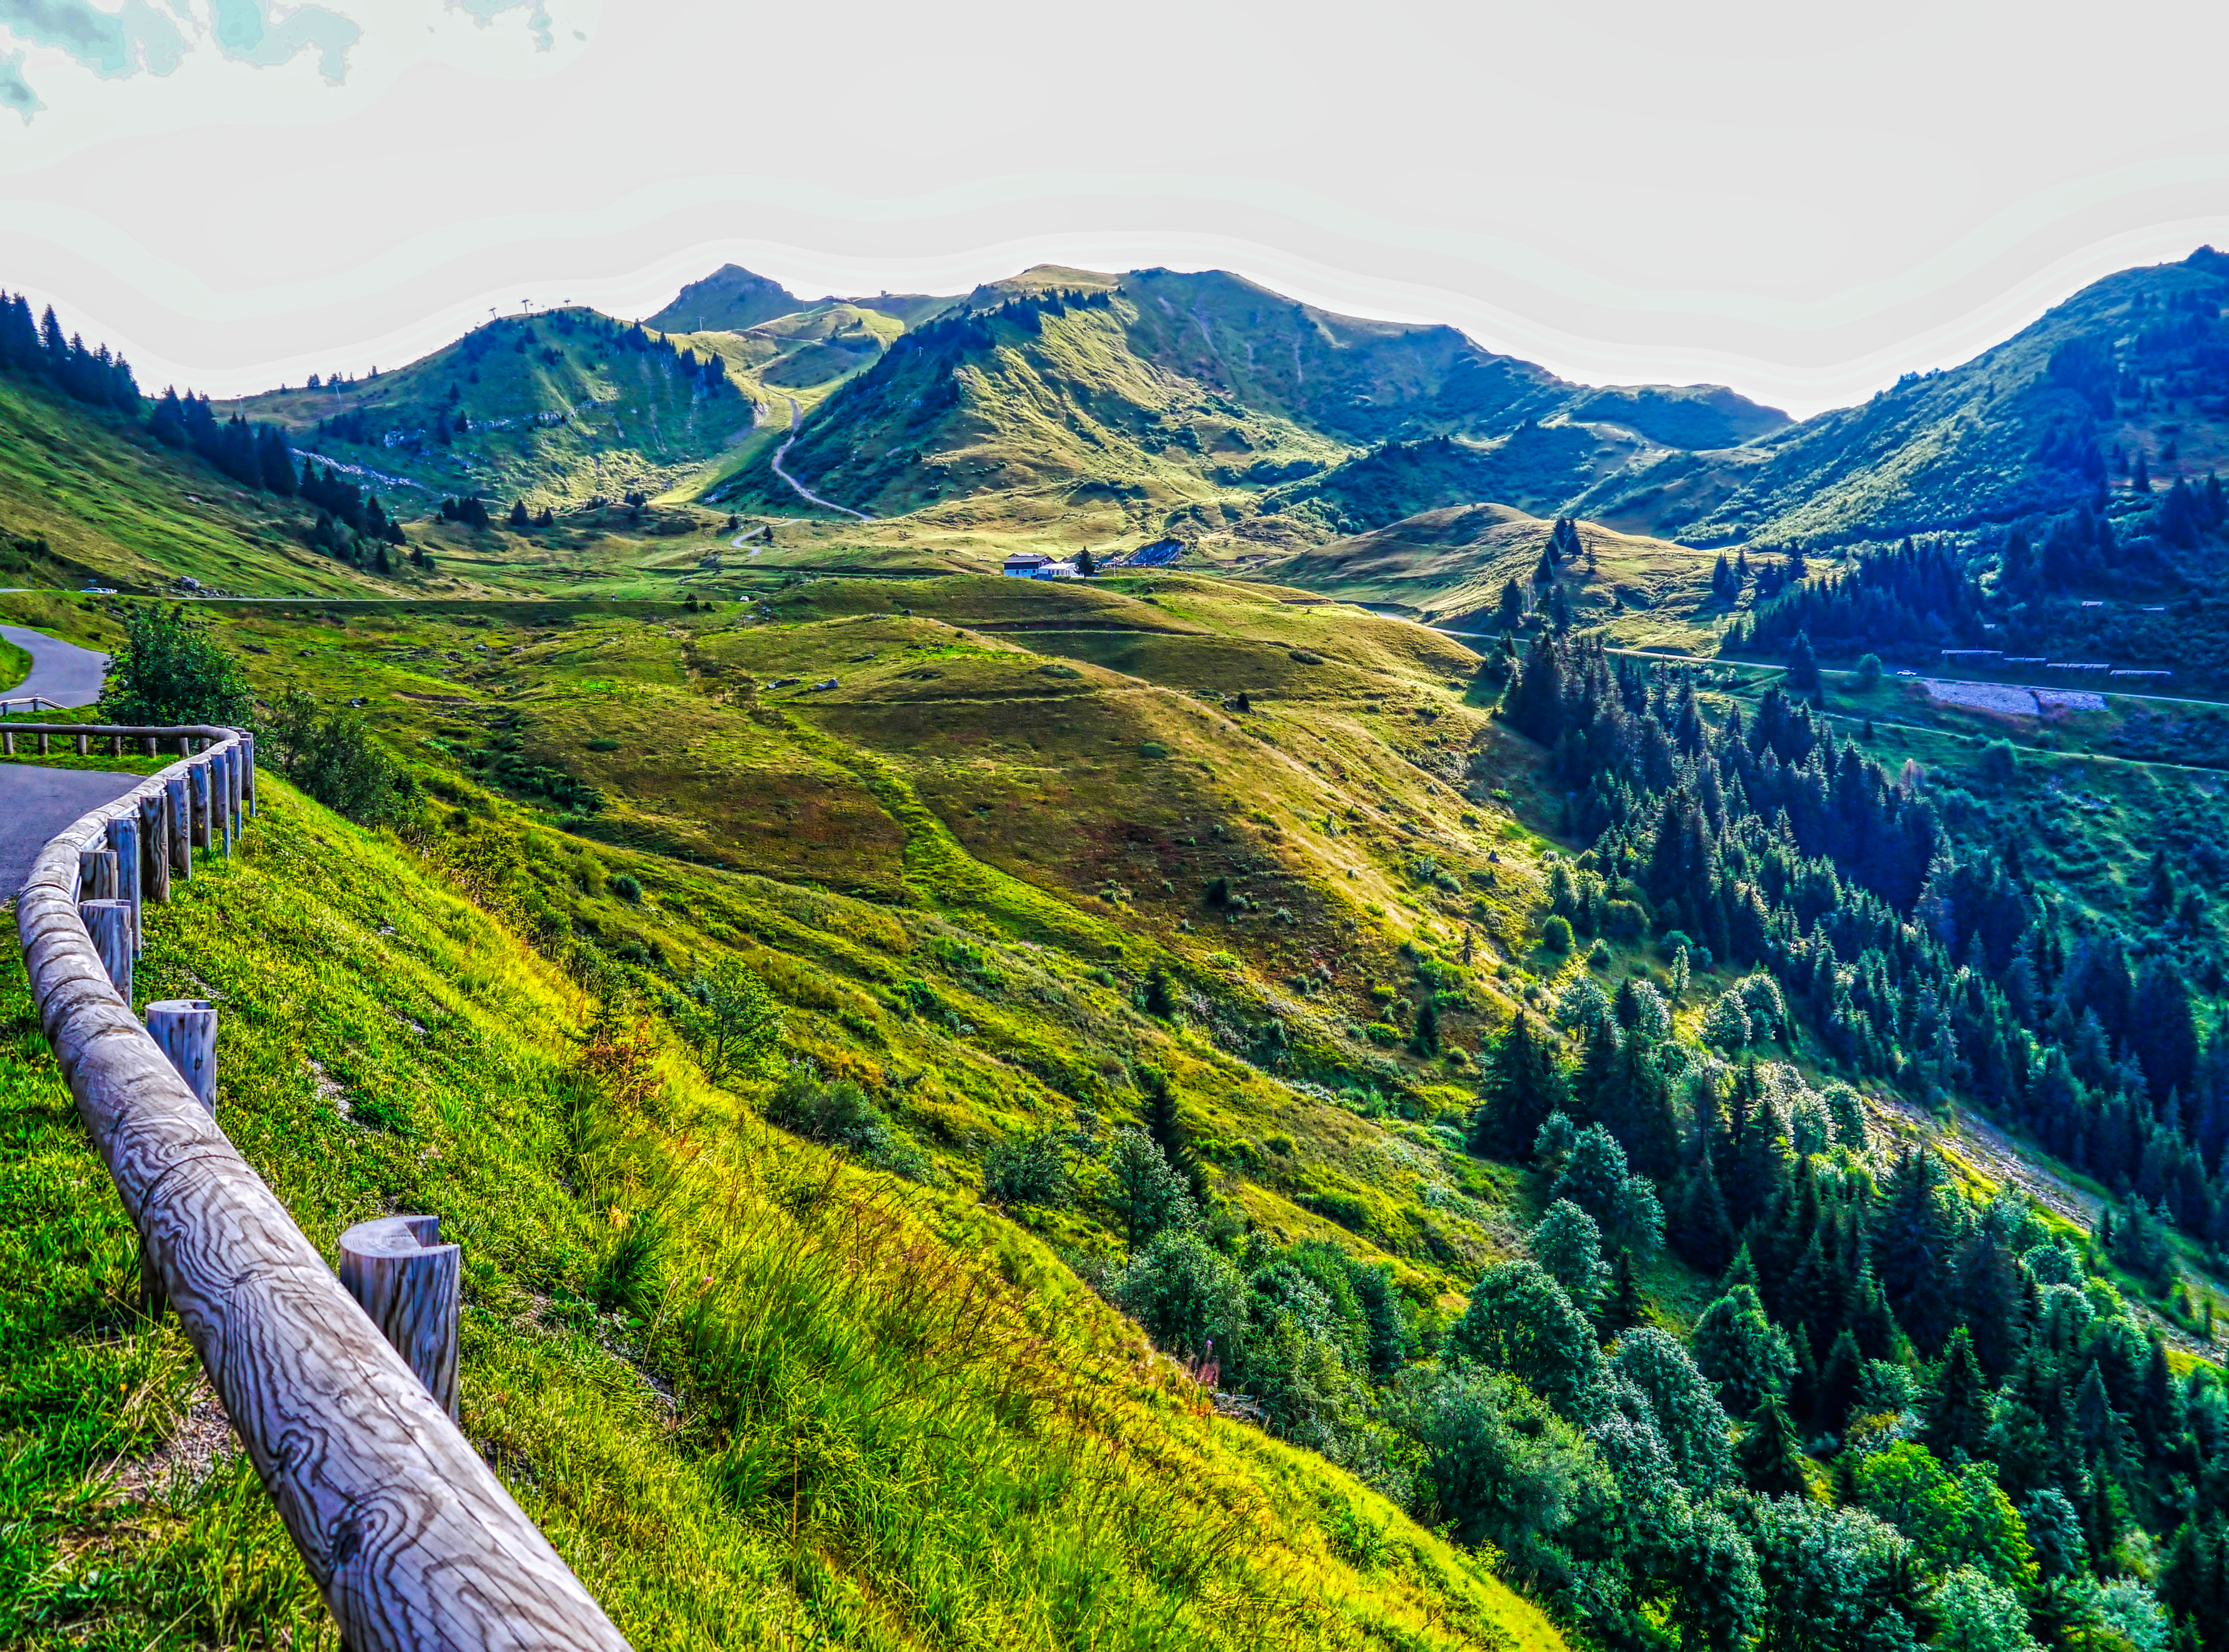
top-left (0, 780), bottom-right (1558, 1650)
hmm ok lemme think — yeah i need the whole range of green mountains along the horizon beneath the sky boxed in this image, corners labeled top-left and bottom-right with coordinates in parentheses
top-left (178, 238), bottom-right (2229, 551)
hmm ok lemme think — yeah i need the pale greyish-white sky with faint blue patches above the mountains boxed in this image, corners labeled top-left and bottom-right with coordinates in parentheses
top-left (0, 0), bottom-right (2229, 412)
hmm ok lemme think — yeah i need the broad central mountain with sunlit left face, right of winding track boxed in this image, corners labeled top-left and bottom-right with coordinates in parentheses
top-left (722, 265), bottom-right (1786, 539)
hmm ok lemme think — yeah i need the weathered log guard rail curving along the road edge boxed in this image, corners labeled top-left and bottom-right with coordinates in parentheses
top-left (11, 724), bottom-right (626, 1652)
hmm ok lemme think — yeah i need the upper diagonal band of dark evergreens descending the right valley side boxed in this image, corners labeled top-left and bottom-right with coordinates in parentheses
top-left (1502, 638), bottom-right (2229, 1244)
